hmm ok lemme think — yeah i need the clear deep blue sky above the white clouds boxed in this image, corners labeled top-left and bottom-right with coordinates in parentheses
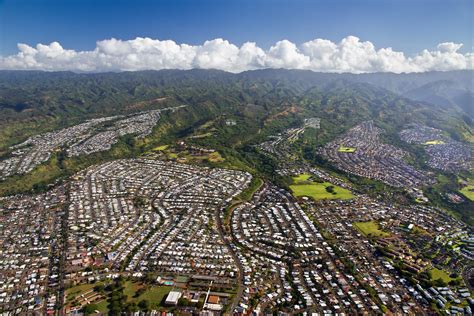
top-left (0, 0), bottom-right (473, 56)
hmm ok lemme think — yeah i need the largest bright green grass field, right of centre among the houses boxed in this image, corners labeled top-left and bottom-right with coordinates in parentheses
top-left (290, 174), bottom-right (354, 200)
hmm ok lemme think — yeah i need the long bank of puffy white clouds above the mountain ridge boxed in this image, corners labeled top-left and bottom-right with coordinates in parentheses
top-left (0, 36), bottom-right (474, 73)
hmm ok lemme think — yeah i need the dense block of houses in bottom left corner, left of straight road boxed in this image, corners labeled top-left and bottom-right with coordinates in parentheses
top-left (0, 187), bottom-right (66, 314)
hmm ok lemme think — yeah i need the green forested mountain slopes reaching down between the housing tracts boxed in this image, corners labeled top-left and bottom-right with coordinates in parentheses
top-left (0, 69), bottom-right (473, 221)
